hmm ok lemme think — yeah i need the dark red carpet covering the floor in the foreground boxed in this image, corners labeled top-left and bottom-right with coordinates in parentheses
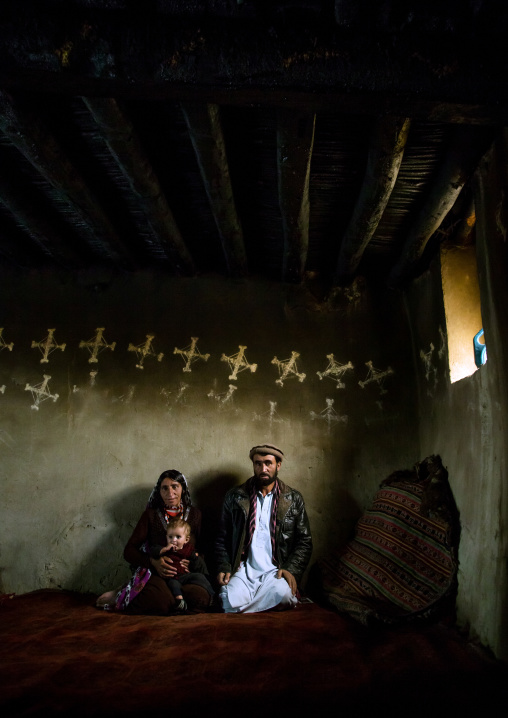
top-left (0, 590), bottom-right (508, 718)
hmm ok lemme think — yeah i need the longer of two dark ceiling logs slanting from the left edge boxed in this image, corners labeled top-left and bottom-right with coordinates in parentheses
top-left (0, 90), bottom-right (134, 268)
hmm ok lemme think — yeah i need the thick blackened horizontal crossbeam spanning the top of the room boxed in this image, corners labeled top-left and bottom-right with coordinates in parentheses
top-left (0, 0), bottom-right (508, 123)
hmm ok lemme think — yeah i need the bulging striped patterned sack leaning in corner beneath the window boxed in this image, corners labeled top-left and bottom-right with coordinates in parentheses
top-left (319, 456), bottom-right (460, 625)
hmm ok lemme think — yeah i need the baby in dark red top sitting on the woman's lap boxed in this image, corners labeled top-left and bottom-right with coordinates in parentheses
top-left (150, 519), bottom-right (214, 612)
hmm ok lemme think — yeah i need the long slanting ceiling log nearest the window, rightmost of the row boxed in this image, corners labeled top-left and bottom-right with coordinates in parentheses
top-left (388, 125), bottom-right (493, 287)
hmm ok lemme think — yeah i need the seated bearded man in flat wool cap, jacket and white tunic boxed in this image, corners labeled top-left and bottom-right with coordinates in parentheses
top-left (215, 444), bottom-right (312, 613)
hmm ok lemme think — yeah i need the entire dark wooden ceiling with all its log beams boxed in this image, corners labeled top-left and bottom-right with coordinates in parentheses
top-left (0, 0), bottom-right (508, 288)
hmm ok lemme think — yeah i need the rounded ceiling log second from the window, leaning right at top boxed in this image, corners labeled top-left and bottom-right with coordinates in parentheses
top-left (335, 116), bottom-right (411, 285)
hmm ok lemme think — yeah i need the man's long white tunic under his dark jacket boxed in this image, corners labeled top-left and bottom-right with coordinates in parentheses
top-left (220, 491), bottom-right (298, 613)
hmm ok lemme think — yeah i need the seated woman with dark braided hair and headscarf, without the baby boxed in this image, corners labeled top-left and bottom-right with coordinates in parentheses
top-left (96, 469), bottom-right (210, 616)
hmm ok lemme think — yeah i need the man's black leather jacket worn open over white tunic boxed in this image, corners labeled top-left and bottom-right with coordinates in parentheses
top-left (215, 479), bottom-right (312, 582)
